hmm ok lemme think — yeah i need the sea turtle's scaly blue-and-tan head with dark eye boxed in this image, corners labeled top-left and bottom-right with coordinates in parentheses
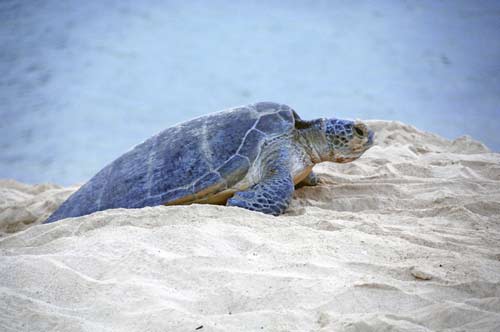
top-left (321, 119), bottom-right (374, 163)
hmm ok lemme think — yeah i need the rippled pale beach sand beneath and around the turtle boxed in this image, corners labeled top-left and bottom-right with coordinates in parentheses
top-left (0, 121), bottom-right (500, 331)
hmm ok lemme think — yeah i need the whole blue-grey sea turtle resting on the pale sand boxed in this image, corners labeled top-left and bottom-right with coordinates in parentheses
top-left (46, 102), bottom-right (373, 223)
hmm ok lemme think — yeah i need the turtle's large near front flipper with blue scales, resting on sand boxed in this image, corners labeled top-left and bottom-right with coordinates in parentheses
top-left (227, 150), bottom-right (294, 216)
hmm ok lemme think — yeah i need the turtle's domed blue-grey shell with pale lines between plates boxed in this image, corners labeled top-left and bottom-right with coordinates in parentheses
top-left (46, 102), bottom-right (298, 222)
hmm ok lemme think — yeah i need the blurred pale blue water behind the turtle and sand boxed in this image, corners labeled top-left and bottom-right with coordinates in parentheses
top-left (0, 0), bottom-right (500, 185)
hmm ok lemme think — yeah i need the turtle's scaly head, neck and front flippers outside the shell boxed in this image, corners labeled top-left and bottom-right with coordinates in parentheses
top-left (227, 119), bottom-right (373, 216)
